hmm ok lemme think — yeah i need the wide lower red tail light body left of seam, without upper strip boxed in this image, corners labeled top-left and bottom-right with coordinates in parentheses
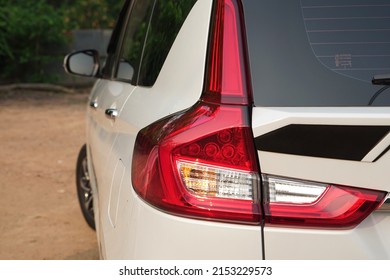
top-left (132, 103), bottom-right (261, 224)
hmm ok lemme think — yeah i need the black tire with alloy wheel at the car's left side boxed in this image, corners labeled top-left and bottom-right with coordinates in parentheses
top-left (76, 144), bottom-right (95, 229)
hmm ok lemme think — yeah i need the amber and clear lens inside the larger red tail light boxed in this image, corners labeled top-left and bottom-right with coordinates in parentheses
top-left (177, 161), bottom-right (257, 200)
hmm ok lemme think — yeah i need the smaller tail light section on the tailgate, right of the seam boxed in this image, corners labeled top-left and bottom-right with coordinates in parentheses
top-left (262, 174), bottom-right (386, 228)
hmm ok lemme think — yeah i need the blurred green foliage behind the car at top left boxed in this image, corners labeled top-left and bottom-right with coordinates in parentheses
top-left (0, 0), bottom-right (124, 84)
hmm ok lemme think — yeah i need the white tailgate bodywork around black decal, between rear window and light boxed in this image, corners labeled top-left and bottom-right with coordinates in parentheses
top-left (252, 107), bottom-right (390, 191)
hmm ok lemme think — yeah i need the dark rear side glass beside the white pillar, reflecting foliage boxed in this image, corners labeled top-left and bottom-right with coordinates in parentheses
top-left (116, 0), bottom-right (196, 86)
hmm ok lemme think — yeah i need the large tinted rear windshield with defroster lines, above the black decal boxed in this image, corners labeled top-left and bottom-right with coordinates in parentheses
top-left (243, 0), bottom-right (390, 106)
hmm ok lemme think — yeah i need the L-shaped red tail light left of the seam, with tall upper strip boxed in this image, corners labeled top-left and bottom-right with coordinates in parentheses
top-left (132, 0), bottom-right (261, 224)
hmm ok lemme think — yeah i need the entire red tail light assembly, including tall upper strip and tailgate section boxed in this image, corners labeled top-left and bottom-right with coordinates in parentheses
top-left (132, 0), bottom-right (386, 228)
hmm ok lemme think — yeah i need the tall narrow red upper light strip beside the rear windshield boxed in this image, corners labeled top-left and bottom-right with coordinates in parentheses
top-left (202, 0), bottom-right (252, 105)
